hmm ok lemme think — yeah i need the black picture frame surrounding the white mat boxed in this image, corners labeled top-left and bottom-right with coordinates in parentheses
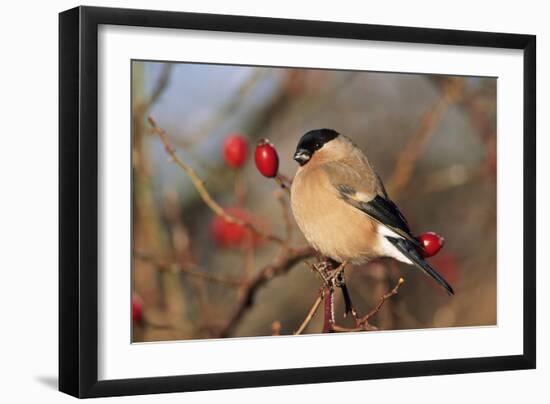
top-left (59, 7), bottom-right (536, 398)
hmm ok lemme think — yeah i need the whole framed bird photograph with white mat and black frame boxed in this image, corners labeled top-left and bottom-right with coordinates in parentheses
top-left (59, 7), bottom-right (536, 397)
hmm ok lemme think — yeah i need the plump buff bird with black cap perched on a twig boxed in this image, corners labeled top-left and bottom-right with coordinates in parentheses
top-left (290, 129), bottom-right (454, 295)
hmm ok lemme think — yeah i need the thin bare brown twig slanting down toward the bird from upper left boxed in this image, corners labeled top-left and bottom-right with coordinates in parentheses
top-left (148, 117), bottom-right (284, 244)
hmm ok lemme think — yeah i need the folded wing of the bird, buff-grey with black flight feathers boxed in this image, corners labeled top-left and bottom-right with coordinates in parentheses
top-left (323, 162), bottom-right (422, 249)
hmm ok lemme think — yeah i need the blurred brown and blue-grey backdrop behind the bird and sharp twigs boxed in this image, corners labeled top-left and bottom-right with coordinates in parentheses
top-left (132, 61), bottom-right (497, 342)
